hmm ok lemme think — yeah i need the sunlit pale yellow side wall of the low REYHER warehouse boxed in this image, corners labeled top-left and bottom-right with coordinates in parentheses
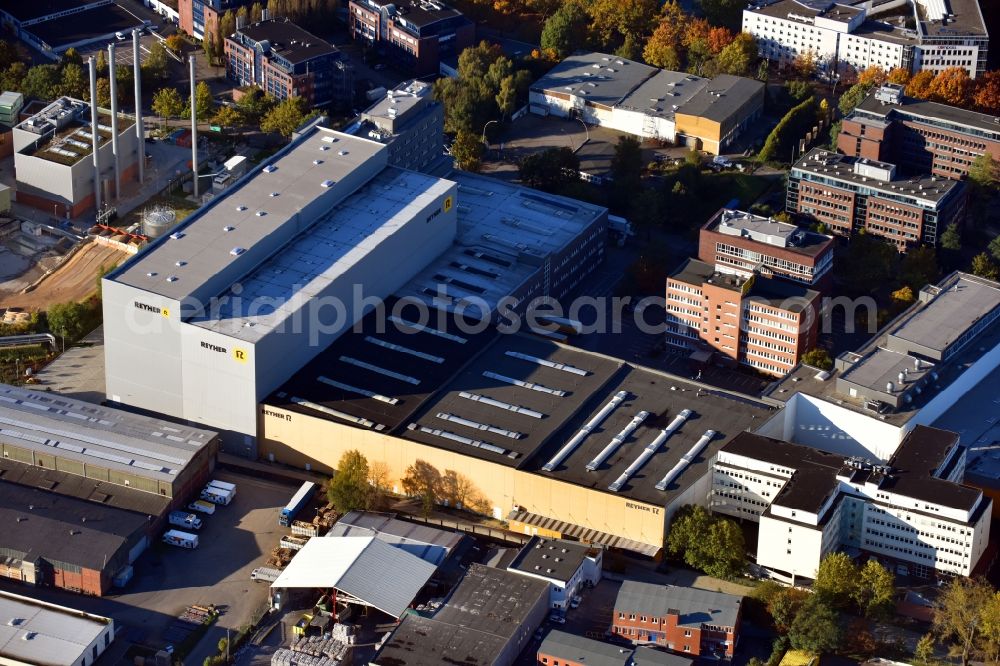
top-left (258, 406), bottom-right (665, 546)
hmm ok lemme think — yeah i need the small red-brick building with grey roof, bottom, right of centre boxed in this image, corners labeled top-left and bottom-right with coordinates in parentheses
top-left (611, 580), bottom-right (743, 659)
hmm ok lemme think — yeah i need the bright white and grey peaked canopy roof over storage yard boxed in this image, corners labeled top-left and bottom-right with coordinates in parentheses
top-left (271, 537), bottom-right (437, 618)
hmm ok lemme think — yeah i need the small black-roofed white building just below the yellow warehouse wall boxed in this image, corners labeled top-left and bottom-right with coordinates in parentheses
top-left (507, 536), bottom-right (604, 609)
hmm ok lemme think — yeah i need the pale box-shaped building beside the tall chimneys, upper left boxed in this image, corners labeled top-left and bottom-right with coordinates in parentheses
top-left (13, 97), bottom-right (138, 218)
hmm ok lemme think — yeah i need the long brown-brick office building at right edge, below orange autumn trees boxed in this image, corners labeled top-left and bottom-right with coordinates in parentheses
top-left (837, 84), bottom-right (1000, 180)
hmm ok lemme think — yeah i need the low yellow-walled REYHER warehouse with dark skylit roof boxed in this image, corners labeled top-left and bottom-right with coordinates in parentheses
top-left (260, 315), bottom-right (771, 555)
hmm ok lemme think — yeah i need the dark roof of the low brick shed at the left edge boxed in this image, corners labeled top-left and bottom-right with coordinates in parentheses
top-left (0, 480), bottom-right (147, 571)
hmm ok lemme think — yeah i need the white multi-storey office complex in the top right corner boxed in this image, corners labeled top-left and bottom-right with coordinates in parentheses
top-left (743, 0), bottom-right (989, 77)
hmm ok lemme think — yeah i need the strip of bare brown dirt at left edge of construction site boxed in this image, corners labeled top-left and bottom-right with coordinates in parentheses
top-left (0, 243), bottom-right (128, 311)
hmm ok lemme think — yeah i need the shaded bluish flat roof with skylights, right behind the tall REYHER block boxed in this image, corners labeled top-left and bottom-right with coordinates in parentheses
top-left (396, 171), bottom-right (607, 313)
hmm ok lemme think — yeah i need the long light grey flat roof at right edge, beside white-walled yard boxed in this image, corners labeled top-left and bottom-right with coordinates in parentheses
top-left (889, 274), bottom-right (1000, 352)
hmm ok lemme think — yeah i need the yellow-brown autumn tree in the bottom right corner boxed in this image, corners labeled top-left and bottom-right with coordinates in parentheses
top-left (932, 576), bottom-right (996, 666)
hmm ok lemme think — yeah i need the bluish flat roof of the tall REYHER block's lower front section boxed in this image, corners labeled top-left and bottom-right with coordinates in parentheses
top-left (189, 167), bottom-right (451, 342)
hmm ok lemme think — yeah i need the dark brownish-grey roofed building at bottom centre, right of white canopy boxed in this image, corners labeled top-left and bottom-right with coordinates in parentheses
top-left (371, 564), bottom-right (548, 666)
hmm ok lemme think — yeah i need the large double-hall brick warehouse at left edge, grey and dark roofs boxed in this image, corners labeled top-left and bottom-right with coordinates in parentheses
top-left (0, 384), bottom-right (217, 595)
